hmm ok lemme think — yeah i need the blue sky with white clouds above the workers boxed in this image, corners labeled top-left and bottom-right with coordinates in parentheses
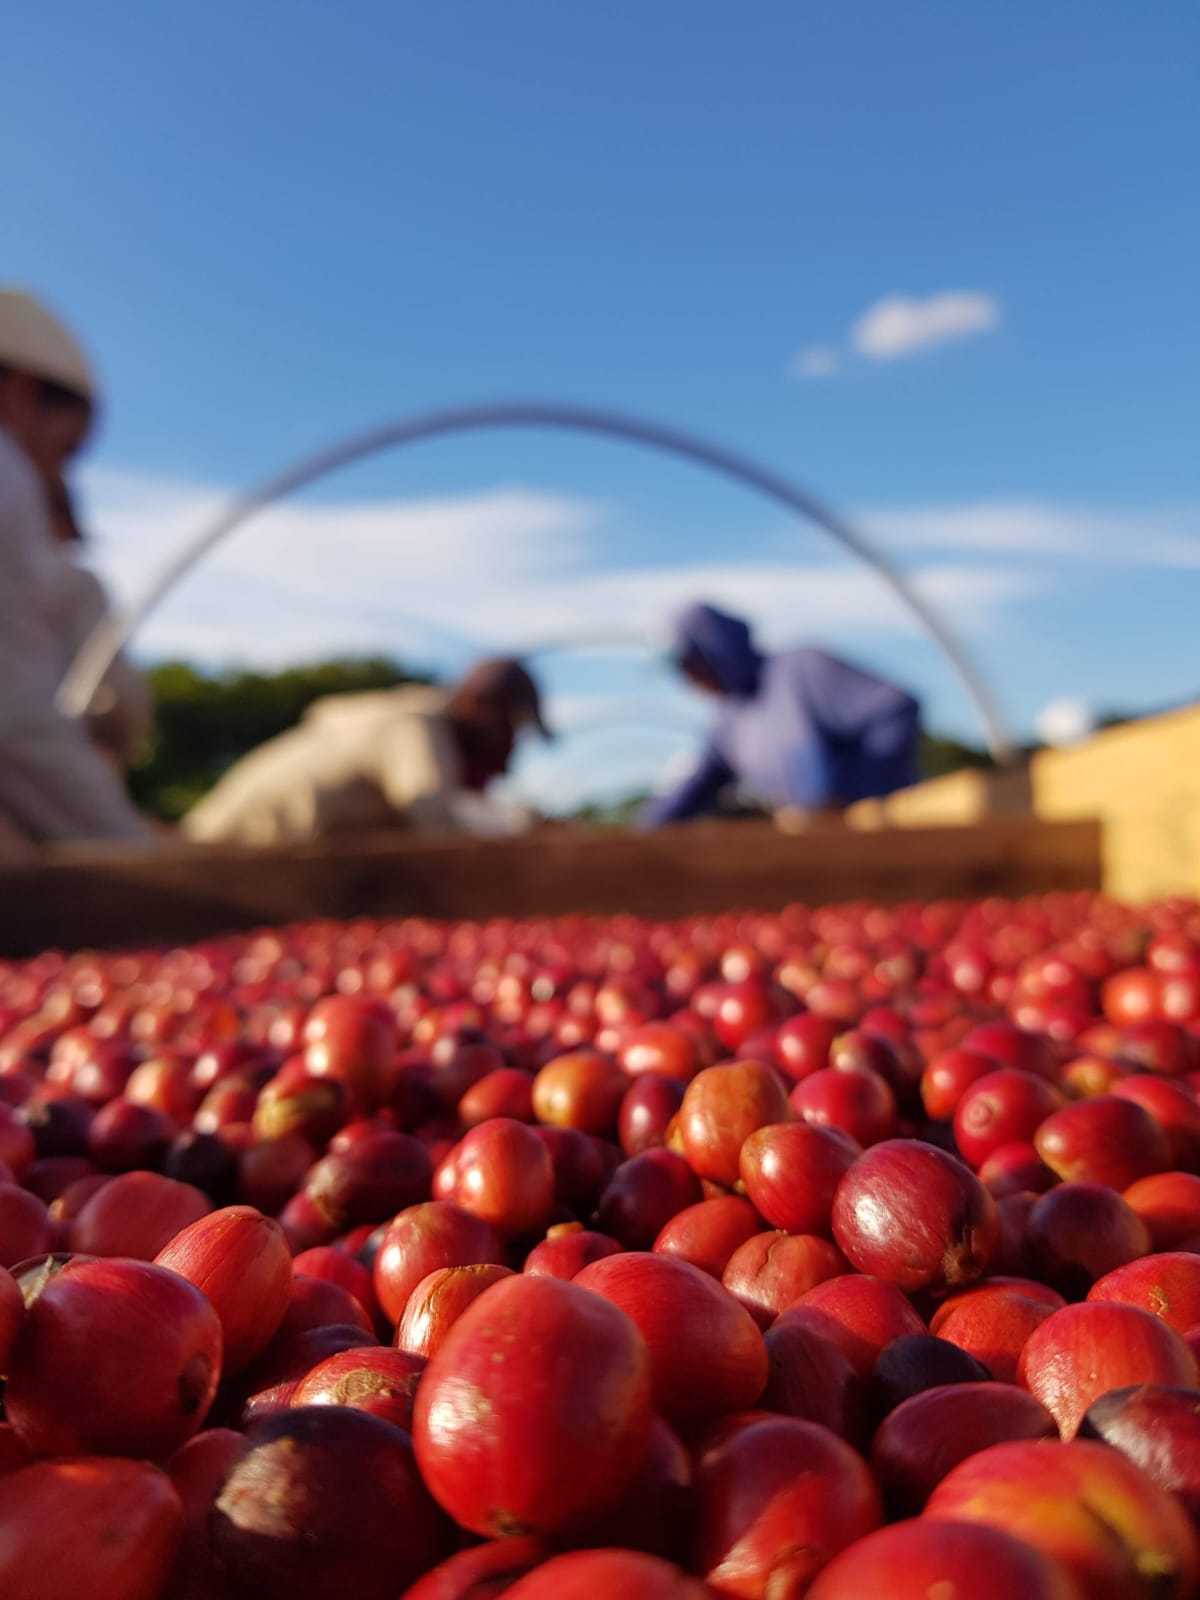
top-left (9, 0), bottom-right (1200, 812)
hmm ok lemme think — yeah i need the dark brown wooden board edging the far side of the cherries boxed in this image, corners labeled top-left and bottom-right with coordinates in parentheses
top-left (0, 819), bottom-right (1101, 957)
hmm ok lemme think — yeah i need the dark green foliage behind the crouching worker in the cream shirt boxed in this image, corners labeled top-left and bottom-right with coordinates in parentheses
top-left (130, 658), bottom-right (429, 822)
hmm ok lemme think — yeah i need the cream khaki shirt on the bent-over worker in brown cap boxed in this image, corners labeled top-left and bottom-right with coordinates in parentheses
top-left (181, 688), bottom-right (528, 846)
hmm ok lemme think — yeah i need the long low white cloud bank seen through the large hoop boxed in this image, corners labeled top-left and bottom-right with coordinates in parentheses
top-left (70, 474), bottom-right (1038, 681)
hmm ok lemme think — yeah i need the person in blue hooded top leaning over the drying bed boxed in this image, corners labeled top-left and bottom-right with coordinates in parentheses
top-left (642, 605), bottom-right (920, 827)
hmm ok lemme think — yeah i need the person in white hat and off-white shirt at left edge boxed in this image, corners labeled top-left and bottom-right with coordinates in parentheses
top-left (0, 288), bottom-right (154, 843)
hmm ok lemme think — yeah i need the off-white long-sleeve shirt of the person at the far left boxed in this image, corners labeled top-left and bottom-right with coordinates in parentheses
top-left (0, 429), bottom-right (150, 843)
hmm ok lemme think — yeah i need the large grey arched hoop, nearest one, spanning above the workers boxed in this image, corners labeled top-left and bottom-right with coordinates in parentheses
top-left (59, 402), bottom-right (1013, 760)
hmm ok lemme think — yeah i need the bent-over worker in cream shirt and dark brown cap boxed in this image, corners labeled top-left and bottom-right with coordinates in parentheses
top-left (182, 659), bottom-right (549, 846)
